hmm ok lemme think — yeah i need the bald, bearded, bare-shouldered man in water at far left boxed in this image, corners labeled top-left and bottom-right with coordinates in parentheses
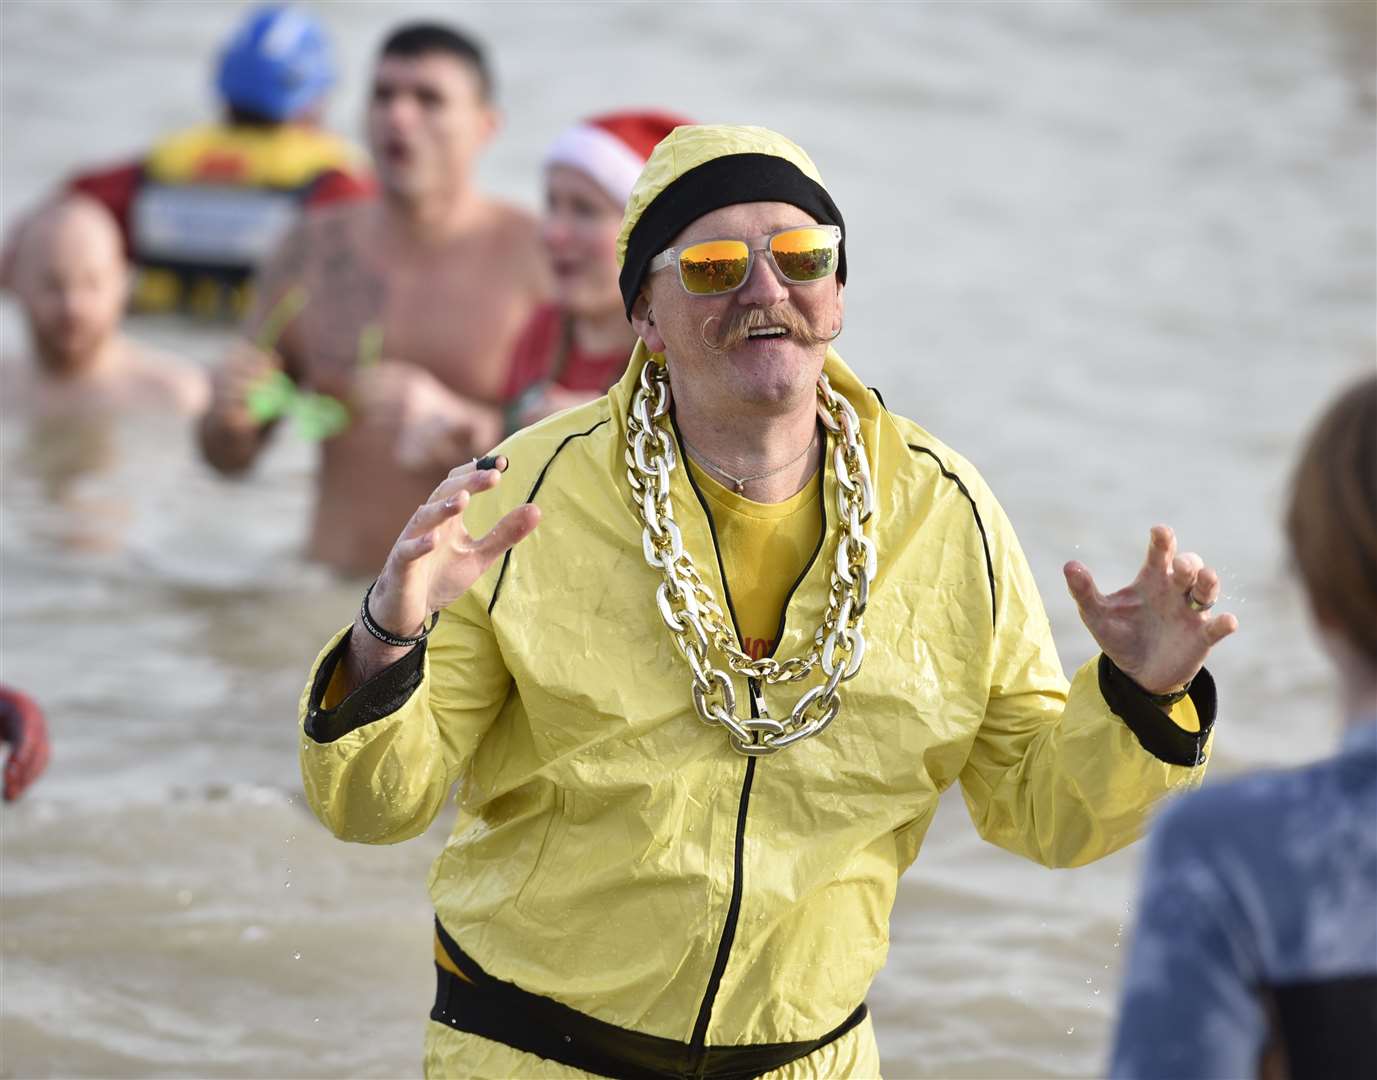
top-left (0, 196), bottom-right (208, 417)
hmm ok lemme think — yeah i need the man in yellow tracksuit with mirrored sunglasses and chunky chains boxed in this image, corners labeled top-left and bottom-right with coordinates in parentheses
top-left (302, 127), bottom-right (1237, 1077)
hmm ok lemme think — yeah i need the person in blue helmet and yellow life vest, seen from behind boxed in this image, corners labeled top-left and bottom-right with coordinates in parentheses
top-left (1, 6), bottom-right (372, 317)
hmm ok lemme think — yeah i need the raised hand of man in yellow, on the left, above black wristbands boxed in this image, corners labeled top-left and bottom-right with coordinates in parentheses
top-left (347, 457), bottom-right (540, 686)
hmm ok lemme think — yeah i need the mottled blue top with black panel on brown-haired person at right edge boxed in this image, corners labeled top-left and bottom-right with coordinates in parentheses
top-left (1110, 718), bottom-right (1377, 1080)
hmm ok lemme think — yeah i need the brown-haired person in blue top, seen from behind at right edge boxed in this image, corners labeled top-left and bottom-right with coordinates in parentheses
top-left (1111, 376), bottom-right (1377, 1080)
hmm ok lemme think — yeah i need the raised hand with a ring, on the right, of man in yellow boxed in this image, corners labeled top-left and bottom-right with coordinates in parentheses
top-left (1062, 525), bottom-right (1238, 694)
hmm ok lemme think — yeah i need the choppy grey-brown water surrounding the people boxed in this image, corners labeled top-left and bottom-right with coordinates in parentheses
top-left (0, 3), bottom-right (1377, 1077)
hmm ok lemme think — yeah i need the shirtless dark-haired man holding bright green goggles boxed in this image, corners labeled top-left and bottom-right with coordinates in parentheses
top-left (201, 23), bottom-right (547, 573)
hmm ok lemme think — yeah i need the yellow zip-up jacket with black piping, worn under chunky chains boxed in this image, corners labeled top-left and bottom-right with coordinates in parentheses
top-left (302, 344), bottom-right (1215, 1068)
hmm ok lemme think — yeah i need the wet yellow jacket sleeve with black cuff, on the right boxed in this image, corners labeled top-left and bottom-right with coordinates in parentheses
top-left (961, 492), bottom-right (1215, 866)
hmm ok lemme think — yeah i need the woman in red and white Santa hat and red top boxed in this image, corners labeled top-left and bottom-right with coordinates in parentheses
top-left (503, 112), bottom-right (693, 431)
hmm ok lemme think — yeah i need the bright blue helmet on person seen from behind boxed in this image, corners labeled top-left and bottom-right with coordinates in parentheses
top-left (215, 6), bottom-right (335, 120)
